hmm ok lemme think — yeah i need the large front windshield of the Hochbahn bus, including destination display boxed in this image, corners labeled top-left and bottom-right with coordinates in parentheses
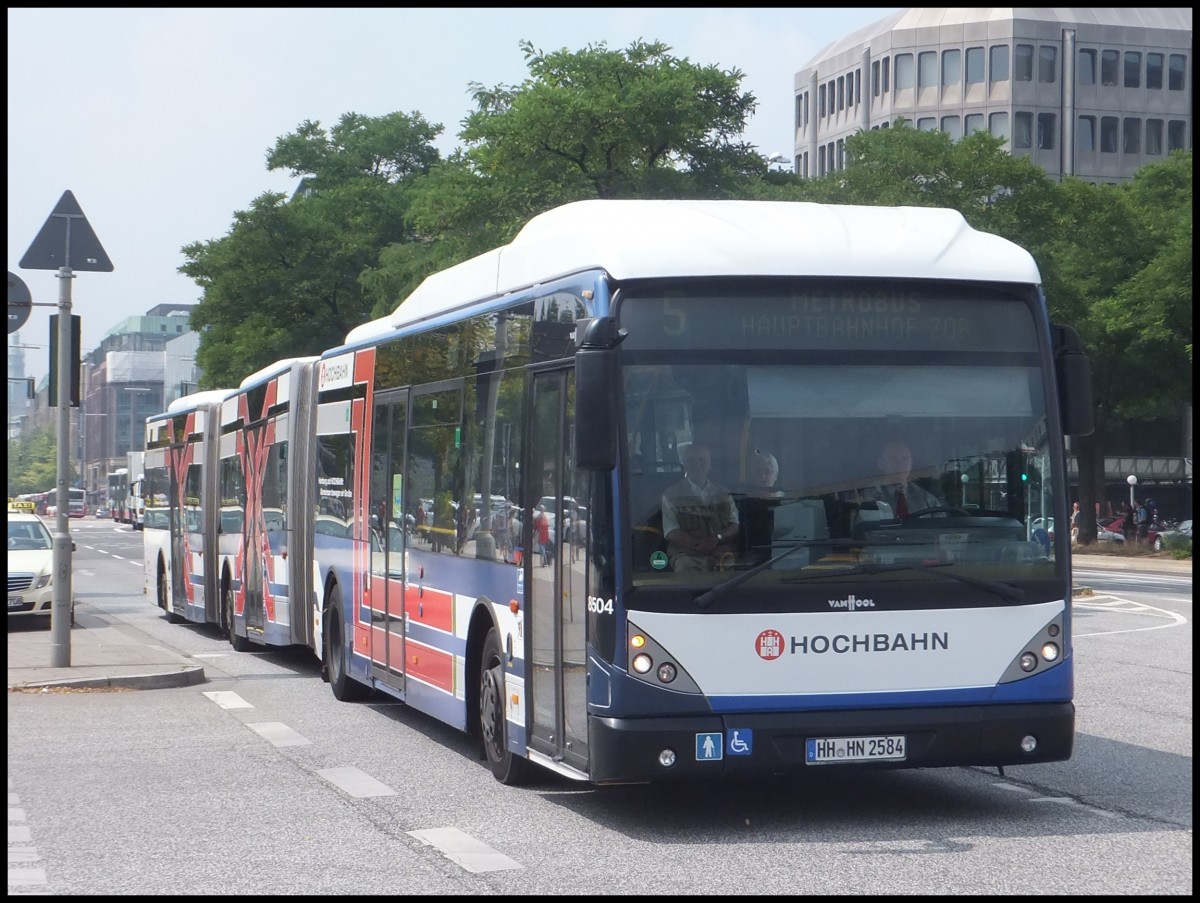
top-left (619, 282), bottom-right (1058, 610)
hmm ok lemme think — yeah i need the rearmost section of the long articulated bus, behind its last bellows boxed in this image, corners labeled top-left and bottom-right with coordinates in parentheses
top-left (143, 389), bottom-right (229, 624)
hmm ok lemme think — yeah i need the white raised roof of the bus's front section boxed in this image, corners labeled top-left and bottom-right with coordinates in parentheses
top-left (346, 201), bottom-right (1042, 345)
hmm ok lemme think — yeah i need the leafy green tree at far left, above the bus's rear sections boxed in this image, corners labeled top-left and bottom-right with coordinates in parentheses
top-left (180, 113), bottom-right (442, 388)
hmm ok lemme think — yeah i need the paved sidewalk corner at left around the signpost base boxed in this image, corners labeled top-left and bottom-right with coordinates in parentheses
top-left (8, 599), bottom-right (206, 689)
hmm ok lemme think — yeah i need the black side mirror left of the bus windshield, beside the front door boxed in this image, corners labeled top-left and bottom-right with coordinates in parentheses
top-left (575, 317), bottom-right (626, 471)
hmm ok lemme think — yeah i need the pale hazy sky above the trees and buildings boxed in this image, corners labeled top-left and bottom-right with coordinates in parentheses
top-left (8, 7), bottom-right (902, 378)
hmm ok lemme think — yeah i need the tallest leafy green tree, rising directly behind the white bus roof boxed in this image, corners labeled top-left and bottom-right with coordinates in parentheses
top-left (364, 41), bottom-right (767, 316)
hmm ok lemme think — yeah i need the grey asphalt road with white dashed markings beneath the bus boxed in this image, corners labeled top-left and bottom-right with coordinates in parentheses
top-left (8, 525), bottom-right (1193, 896)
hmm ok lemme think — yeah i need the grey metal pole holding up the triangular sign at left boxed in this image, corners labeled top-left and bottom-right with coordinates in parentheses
top-left (50, 267), bottom-right (74, 668)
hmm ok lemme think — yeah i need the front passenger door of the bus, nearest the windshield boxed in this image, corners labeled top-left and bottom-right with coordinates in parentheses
top-left (524, 369), bottom-right (588, 771)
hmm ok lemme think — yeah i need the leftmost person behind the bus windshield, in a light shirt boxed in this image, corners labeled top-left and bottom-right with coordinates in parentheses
top-left (662, 442), bottom-right (739, 570)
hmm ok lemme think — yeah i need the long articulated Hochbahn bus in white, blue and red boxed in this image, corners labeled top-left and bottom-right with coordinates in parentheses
top-left (146, 201), bottom-right (1091, 783)
